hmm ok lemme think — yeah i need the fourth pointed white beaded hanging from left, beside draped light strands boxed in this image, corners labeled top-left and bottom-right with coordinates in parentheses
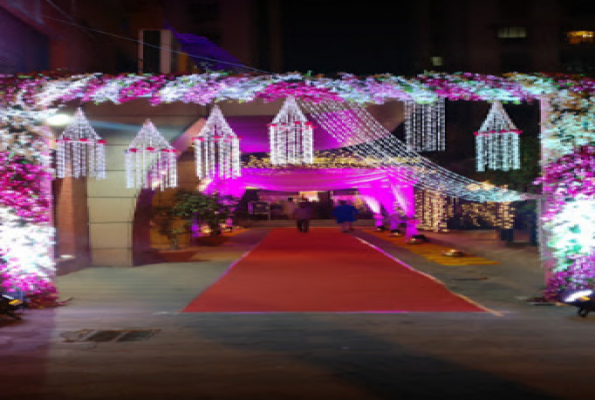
top-left (269, 97), bottom-right (314, 165)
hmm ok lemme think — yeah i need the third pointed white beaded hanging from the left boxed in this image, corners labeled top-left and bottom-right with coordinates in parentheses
top-left (194, 105), bottom-right (241, 179)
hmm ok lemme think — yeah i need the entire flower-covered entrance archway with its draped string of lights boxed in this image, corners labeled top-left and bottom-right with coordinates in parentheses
top-left (0, 72), bottom-right (595, 300)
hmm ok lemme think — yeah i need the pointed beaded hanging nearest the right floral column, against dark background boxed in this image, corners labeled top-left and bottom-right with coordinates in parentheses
top-left (475, 101), bottom-right (522, 171)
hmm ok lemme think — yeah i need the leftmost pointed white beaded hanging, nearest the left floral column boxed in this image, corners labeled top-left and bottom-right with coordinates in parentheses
top-left (56, 108), bottom-right (106, 179)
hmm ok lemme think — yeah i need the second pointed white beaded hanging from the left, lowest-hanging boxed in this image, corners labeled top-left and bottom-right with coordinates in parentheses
top-left (126, 119), bottom-right (178, 190)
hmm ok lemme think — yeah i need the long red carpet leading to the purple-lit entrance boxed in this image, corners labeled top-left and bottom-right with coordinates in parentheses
top-left (184, 228), bottom-right (485, 312)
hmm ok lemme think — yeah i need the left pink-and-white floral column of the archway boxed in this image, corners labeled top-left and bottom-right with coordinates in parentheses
top-left (0, 112), bottom-right (57, 307)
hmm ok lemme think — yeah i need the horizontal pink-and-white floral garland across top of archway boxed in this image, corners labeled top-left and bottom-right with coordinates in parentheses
top-left (0, 71), bottom-right (595, 105)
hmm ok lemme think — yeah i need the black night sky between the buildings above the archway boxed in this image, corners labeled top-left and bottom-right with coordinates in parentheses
top-left (281, 0), bottom-right (411, 75)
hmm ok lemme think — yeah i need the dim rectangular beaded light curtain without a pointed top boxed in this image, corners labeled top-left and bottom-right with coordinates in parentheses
top-left (405, 97), bottom-right (446, 151)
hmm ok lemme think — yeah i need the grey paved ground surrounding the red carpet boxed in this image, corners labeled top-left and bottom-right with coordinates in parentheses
top-left (0, 229), bottom-right (595, 400)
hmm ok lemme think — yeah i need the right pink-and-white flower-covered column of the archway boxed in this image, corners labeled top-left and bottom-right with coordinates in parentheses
top-left (537, 93), bottom-right (595, 300)
